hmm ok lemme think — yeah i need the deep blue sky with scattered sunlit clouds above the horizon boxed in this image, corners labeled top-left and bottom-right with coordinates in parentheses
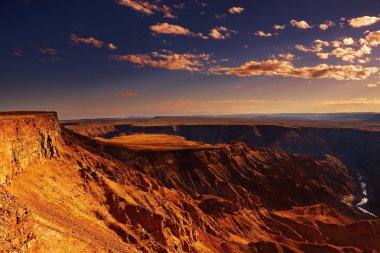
top-left (0, 0), bottom-right (380, 119)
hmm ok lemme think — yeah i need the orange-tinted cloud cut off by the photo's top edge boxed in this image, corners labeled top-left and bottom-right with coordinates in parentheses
top-left (118, 0), bottom-right (176, 18)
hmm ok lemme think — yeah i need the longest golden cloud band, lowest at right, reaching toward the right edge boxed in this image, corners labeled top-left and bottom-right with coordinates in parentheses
top-left (209, 59), bottom-right (379, 80)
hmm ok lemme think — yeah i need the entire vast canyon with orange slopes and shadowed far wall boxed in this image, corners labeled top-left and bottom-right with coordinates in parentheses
top-left (0, 112), bottom-right (380, 253)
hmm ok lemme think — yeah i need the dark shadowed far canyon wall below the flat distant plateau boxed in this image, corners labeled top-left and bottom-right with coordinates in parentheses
top-left (76, 123), bottom-right (380, 216)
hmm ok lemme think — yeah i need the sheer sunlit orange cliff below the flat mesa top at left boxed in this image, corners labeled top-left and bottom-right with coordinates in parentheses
top-left (0, 113), bottom-right (62, 185)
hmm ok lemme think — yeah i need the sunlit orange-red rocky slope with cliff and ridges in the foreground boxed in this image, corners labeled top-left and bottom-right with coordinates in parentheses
top-left (0, 114), bottom-right (380, 253)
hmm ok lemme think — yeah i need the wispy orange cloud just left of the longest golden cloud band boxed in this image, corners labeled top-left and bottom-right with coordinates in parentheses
top-left (110, 50), bottom-right (210, 72)
